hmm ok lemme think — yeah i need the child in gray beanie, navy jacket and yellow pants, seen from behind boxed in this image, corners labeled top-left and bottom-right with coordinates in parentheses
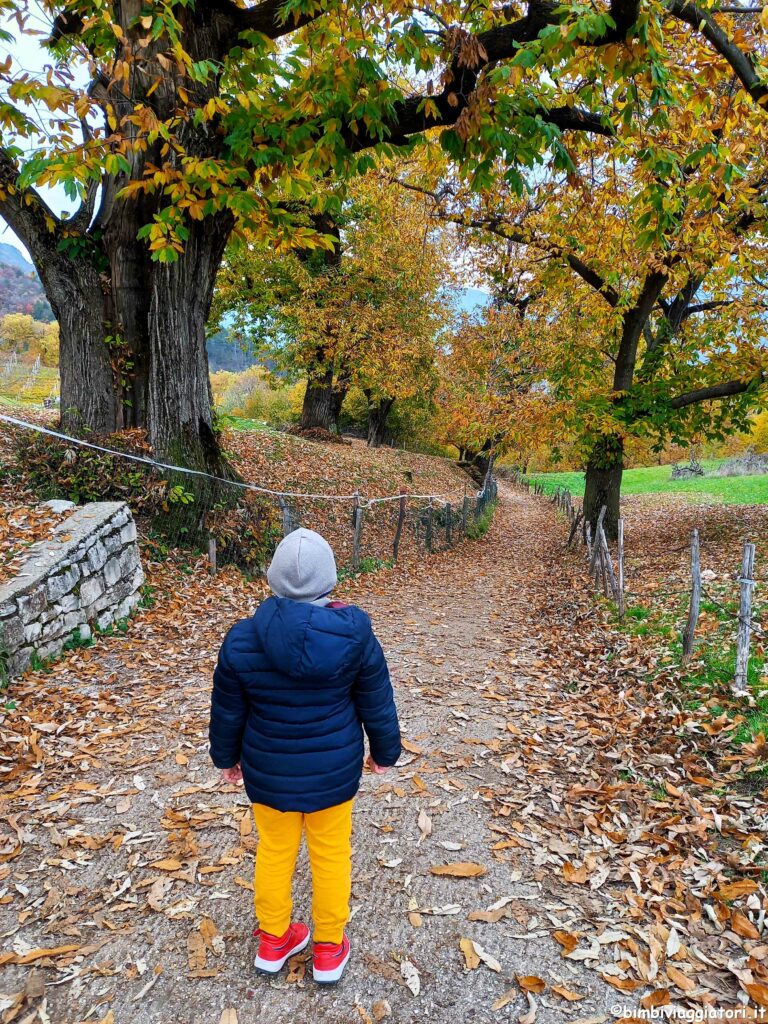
top-left (210, 529), bottom-right (400, 984)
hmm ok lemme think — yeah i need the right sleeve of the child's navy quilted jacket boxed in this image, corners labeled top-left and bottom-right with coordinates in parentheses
top-left (352, 630), bottom-right (400, 768)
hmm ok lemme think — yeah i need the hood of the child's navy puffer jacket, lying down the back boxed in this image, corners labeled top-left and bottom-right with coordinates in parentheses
top-left (253, 597), bottom-right (371, 681)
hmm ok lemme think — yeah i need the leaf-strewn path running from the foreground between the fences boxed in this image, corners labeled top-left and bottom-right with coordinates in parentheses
top-left (0, 490), bottom-right (655, 1024)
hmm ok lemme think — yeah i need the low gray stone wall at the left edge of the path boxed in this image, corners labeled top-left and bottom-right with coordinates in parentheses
top-left (0, 502), bottom-right (144, 676)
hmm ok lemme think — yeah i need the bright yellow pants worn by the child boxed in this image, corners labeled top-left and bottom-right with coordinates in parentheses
top-left (253, 800), bottom-right (353, 942)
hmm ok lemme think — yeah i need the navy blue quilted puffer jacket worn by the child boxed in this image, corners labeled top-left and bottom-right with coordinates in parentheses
top-left (210, 597), bottom-right (400, 813)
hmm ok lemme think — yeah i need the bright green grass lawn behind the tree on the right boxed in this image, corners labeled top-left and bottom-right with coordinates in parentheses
top-left (528, 461), bottom-right (768, 505)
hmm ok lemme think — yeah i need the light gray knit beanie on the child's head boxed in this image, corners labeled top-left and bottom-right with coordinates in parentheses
top-left (266, 527), bottom-right (338, 601)
